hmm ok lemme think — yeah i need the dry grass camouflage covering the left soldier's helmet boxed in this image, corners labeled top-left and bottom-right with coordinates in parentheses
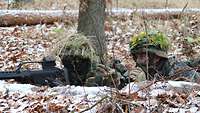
top-left (54, 33), bottom-right (98, 61)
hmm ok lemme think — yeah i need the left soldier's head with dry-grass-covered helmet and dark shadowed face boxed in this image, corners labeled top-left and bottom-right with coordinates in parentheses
top-left (51, 32), bottom-right (98, 85)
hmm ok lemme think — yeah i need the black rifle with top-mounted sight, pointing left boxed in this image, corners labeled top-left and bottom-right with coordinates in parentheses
top-left (0, 56), bottom-right (69, 87)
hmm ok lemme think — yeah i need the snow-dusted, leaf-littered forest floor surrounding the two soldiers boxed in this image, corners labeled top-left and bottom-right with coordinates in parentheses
top-left (0, 0), bottom-right (200, 113)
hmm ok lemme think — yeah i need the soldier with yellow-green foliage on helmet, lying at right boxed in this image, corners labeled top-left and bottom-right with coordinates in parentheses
top-left (130, 31), bottom-right (200, 82)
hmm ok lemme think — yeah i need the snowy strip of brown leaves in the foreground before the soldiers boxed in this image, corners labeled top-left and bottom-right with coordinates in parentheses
top-left (0, 81), bottom-right (200, 113)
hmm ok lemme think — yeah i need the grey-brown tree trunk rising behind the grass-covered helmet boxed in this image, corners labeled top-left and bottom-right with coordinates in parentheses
top-left (78, 0), bottom-right (107, 63)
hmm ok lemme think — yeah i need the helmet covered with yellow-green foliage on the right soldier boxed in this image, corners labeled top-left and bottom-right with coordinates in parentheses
top-left (129, 31), bottom-right (170, 58)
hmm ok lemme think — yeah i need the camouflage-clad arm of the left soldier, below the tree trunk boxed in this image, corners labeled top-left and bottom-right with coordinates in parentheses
top-left (85, 60), bottom-right (128, 89)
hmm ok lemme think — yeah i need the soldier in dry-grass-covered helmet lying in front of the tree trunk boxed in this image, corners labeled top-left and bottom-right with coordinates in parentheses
top-left (55, 34), bottom-right (128, 88)
